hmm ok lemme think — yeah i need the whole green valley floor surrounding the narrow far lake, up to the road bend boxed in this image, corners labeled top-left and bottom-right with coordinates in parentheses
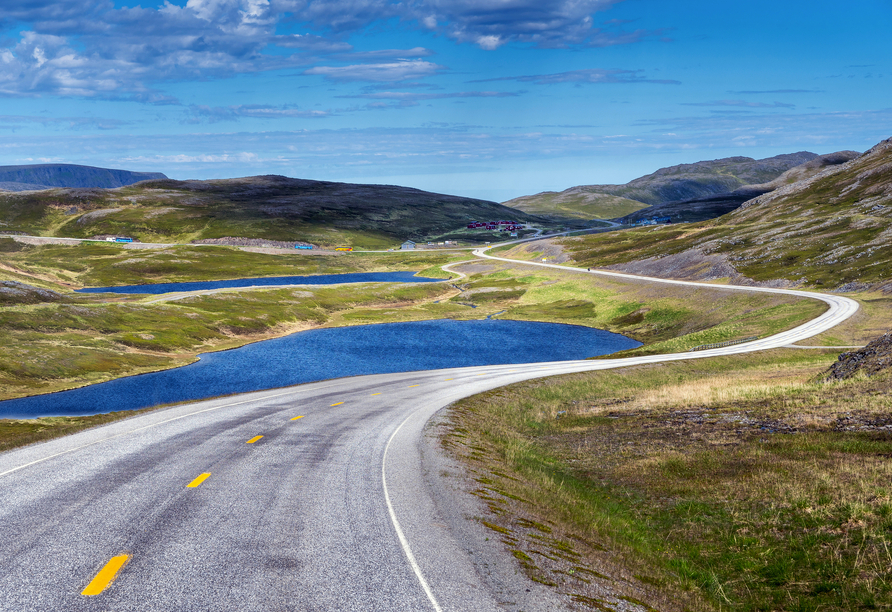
top-left (0, 249), bottom-right (823, 454)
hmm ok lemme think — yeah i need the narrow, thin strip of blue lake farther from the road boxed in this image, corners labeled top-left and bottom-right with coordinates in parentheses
top-left (77, 271), bottom-right (443, 295)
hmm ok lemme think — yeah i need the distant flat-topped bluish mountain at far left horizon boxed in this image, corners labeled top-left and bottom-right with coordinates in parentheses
top-left (0, 164), bottom-right (167, 191)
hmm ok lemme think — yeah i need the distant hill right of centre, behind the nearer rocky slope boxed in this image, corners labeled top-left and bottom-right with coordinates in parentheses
top-left (504, 151), bottom-right (818, 219)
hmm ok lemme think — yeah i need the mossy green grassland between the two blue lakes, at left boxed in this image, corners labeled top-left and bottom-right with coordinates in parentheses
top-left (0, 284), bottom-right (454, 399)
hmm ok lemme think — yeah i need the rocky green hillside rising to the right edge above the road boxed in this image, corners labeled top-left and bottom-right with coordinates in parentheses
top-left (528, 138), bottom-right (892, 292)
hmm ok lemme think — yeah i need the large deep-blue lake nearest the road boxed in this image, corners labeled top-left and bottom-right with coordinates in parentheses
top-left (0, 319), bottom-right (641, 418)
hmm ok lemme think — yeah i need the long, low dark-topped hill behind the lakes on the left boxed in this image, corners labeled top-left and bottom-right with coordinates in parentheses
top-left (0, 176), bottom-right (542, 248)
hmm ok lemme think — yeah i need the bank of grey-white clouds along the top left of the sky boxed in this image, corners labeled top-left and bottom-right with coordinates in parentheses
top-left (0, 0), bottom-right (654, 97)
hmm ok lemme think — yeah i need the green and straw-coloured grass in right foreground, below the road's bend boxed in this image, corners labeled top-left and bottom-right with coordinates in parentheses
top-left (443, 351), bottom-right (892, 611)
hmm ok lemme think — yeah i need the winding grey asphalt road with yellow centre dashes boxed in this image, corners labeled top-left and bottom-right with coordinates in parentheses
top-left (0, 250), bottom-right (858, 611)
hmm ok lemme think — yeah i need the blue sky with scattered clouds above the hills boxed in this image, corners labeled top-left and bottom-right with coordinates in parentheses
top-left (0, 0), bottom-right (892, 202)
